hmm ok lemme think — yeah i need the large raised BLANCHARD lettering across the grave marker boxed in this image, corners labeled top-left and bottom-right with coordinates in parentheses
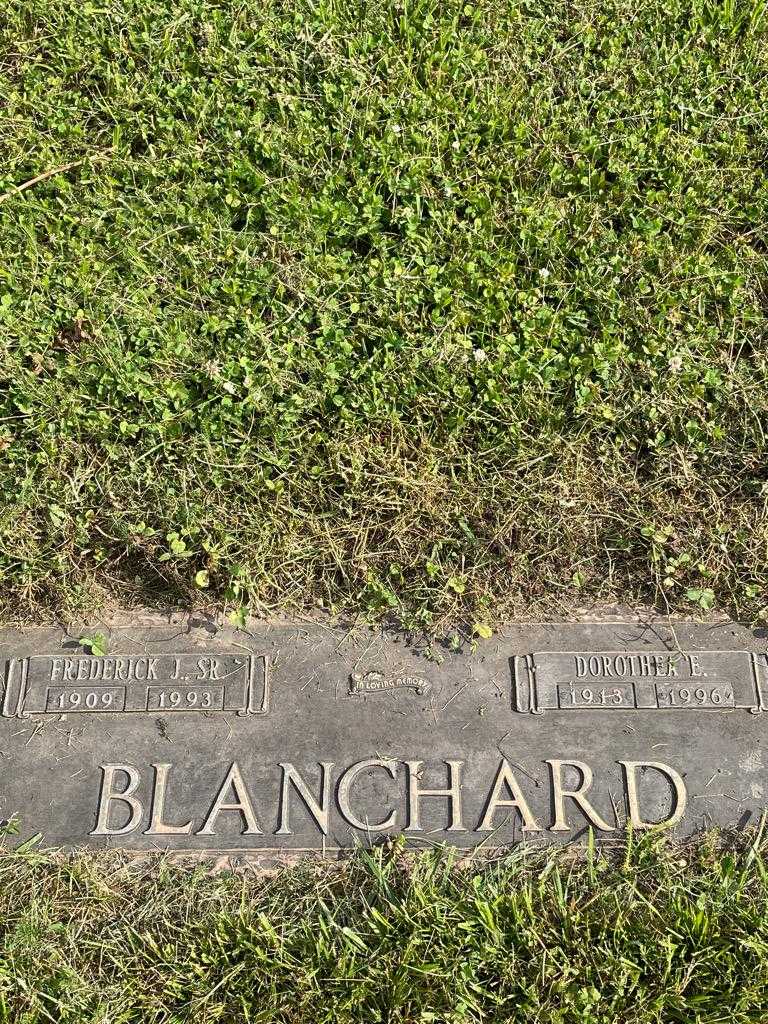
top-left (90, 758), bottom-right (687, 837)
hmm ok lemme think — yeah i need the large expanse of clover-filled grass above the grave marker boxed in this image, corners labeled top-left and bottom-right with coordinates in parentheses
top-left (0, 0), bottom-right (768, 627)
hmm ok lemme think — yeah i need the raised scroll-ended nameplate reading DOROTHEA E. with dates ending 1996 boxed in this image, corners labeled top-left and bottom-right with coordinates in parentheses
top-left (512, 650), bottom-right (768, 715)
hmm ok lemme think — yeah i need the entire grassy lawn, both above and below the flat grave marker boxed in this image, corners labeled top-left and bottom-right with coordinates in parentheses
top-left (0, 0), bottom-right (768, 1024)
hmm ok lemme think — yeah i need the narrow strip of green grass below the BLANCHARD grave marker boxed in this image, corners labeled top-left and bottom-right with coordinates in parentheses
top-left (0, 836), bottom-right (768, 1024)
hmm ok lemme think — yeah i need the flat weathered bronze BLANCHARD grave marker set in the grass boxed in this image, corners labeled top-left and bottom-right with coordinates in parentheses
top-left (0, 623), bottom-right (768, 856)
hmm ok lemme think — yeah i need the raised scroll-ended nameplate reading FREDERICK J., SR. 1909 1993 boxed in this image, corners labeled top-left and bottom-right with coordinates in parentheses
top-left (2, 653), bottom-right (269, 718)
